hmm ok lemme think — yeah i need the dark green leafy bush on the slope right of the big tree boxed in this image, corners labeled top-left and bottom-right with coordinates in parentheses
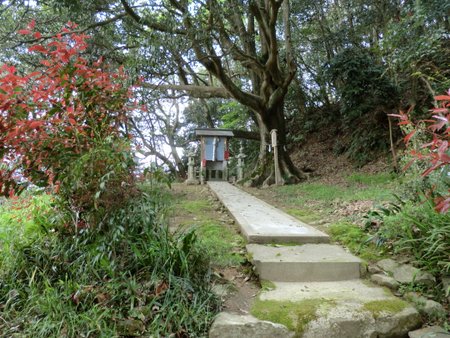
top-left (327, 48), bottom-right (398, 164)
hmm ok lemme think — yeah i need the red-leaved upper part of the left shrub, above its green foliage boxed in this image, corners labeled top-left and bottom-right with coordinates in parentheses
top-left (0, 22), bottom-right (130, 195)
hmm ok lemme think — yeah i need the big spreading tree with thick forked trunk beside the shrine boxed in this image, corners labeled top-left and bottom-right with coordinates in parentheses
top-left (4, 0), bottom-right (301, 184)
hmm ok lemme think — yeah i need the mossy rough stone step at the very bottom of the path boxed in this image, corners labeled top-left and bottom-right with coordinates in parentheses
top-left (210, 280), bottom-right (421, 338)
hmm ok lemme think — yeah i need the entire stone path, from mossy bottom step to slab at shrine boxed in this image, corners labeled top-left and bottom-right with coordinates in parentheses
top-left (208, 182), bottom-right (421, 338)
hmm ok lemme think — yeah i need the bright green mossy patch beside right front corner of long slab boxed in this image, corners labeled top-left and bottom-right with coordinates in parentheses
top-left (329, 222), bottom-right (386, 262)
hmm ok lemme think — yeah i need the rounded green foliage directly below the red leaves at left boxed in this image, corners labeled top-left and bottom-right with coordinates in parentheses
top-left (57, 138), bottom-right (136, 228)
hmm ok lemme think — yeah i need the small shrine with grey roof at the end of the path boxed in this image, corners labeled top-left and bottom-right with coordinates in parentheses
top-left (195, 129), bottom-right (234, 183)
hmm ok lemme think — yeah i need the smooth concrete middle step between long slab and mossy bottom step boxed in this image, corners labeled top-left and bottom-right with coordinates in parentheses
top-left (247, 244), bottom-right (361, 282)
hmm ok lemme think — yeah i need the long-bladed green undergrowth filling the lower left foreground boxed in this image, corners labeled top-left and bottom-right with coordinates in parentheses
top-left (0, 186), bottom-right (219, 337)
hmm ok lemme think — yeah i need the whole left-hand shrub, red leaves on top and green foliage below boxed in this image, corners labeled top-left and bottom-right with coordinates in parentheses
top-left (0, 23), bottom-right (133, 226)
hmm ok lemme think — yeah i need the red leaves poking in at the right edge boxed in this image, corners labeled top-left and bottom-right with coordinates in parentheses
top-left (394, 90), bottom-right (450, 213)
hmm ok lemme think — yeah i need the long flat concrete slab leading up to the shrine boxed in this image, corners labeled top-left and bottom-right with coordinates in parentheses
top-left (208, 181), bottom-right (329, 244)
